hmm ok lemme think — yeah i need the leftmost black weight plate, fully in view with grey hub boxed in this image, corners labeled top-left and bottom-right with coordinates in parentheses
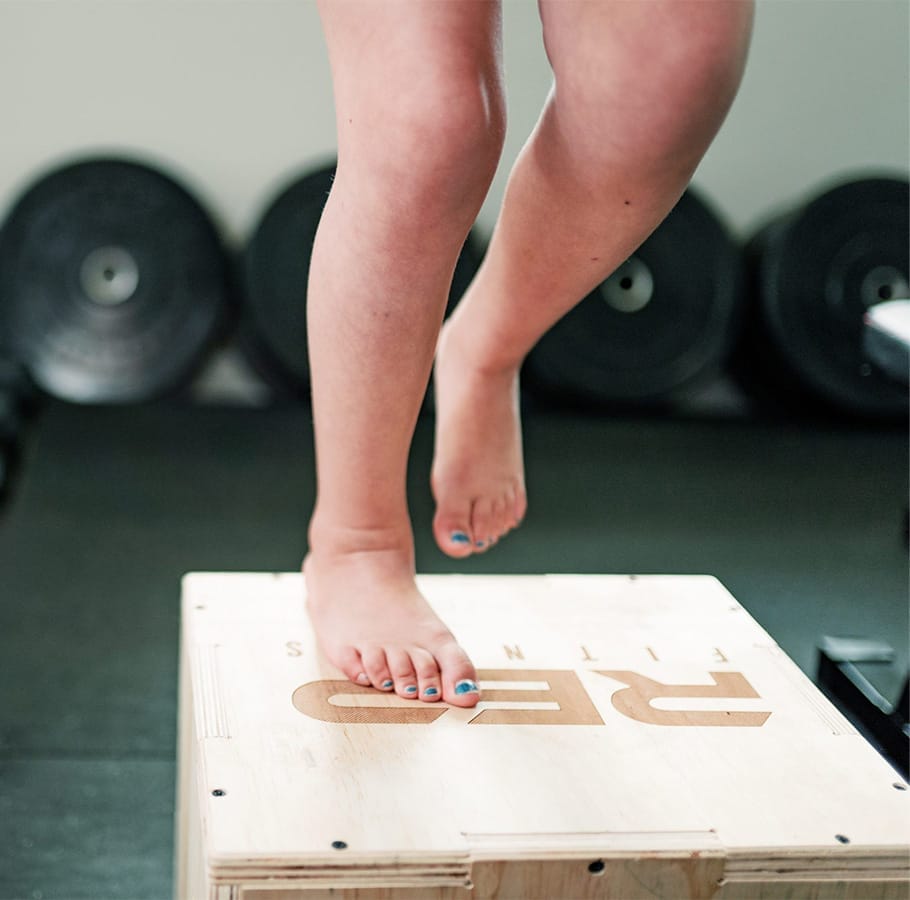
top-left (0, 159), bottom-right (228, 403)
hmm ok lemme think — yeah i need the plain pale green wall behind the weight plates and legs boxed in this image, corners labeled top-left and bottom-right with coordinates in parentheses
top-left (0, 0), bottom-right (910, 243)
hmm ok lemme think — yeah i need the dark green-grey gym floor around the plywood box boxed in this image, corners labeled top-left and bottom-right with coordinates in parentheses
top-left (0, 404), bottom-right (908, 900)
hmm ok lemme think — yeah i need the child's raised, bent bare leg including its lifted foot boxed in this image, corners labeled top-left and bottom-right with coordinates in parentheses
top-left (432, 0), bottom-right (752, 555)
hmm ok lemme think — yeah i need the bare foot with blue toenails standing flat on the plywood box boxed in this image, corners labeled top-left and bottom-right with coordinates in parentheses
top-left (303, 525), bottom-right (480, 707)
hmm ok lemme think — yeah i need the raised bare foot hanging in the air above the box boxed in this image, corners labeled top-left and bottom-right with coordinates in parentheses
top-left (430, 323), bottom-right (528, 557)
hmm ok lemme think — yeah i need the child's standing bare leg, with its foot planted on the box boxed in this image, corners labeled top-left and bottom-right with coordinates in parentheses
top-left (301, 0), bottom-right (504, 706)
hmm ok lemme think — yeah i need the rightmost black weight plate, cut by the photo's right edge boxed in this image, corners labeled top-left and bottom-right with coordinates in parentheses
top-left (747, 178), bottom-right (910, 419)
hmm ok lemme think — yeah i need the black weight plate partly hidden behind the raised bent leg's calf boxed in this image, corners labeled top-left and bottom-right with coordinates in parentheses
top-left (524, 189), bottom-right (743, 408)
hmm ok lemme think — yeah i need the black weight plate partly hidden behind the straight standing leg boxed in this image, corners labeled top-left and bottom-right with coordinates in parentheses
top-left (241, 164), bottom-right (480, 396)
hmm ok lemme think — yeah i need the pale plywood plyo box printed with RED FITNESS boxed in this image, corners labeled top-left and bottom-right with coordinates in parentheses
top-left (177, 574), bottom-right (910, 900)
